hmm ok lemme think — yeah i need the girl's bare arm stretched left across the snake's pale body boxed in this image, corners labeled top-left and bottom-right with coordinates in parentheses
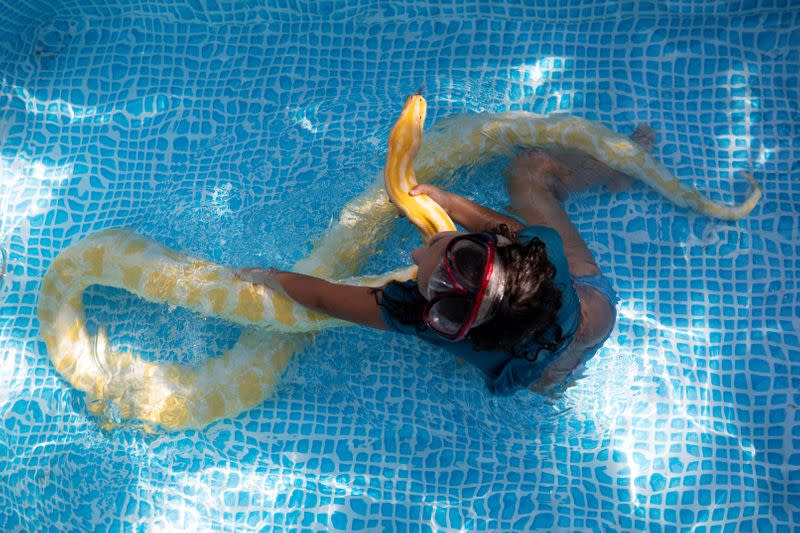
top-left (236, 268), bottom-right (389, 330)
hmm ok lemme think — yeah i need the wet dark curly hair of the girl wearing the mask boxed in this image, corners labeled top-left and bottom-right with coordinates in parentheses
top-left (380, 224), bottom-right (563, 360)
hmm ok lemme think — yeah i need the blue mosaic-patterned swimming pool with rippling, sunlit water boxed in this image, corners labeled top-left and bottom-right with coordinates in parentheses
top-left (0, 0), bottom-right (800, 531)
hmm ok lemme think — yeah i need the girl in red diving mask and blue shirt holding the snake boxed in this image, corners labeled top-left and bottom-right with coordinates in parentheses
top-left (238, 130), bottom-right (653, 394)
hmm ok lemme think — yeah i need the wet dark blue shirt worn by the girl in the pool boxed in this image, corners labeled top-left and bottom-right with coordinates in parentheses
top-left (381, 226), bottom-right (580, 394)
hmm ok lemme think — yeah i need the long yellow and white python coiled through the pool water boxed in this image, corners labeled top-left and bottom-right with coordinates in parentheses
top-left (38, 94), bottom-right (761, 431)
